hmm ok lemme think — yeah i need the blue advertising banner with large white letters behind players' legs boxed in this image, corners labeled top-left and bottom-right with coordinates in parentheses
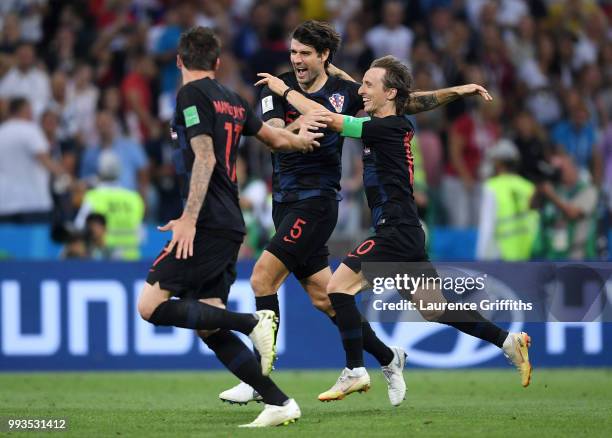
top-left (0, 261), bottom-right (612, 371)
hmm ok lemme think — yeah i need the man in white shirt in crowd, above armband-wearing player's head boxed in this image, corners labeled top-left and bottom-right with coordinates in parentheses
top-left (366, 0), bottom-right (414, 64)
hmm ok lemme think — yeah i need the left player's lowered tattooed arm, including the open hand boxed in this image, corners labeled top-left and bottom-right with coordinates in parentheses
top-left (158, 135), bottom-right (217, 259)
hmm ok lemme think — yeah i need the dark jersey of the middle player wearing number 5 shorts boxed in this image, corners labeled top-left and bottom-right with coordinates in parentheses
top-left (261, 72), bottom-right (363, 202)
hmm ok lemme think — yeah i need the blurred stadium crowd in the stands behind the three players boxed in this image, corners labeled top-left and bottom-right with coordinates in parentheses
top-left (0, 0), bottom-right (612, 258)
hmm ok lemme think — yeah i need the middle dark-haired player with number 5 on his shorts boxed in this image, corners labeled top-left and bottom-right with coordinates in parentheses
top-left (219, 21), bottom-right (492, 406)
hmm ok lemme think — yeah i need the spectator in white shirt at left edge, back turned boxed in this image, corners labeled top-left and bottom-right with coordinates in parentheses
top-left (0, 98), bottom-right (63, 223)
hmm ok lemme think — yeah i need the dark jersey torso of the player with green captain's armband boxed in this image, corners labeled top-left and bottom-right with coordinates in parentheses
top-left (361, 116), bottom-right (420, 227)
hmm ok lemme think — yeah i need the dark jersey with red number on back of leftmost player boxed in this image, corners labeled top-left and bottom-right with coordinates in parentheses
top-left (172, 78), bottom-right (262, 239)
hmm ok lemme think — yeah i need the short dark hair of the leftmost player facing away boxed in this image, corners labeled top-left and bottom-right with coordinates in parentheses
top-left (178, 26), bottom-right (221, 71)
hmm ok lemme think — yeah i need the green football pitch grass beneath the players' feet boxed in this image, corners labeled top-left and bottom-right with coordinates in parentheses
top-left (0, 368), bottom-right (612, 438)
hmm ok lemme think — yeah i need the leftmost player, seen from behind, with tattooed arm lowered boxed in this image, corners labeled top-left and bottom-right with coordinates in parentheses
top-left (138, 27), bottom-right (322, 427)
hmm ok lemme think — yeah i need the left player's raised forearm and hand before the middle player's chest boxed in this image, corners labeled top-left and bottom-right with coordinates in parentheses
top-left (256, 114), bottom-right (326, 153)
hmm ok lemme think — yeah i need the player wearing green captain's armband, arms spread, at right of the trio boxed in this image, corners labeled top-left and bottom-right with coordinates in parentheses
top-left (259, 56), bottom-right (531, 401)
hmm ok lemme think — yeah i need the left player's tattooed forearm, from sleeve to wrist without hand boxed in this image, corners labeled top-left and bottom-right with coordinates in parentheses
top-left (183, 135), bottom-right (217, 223)
